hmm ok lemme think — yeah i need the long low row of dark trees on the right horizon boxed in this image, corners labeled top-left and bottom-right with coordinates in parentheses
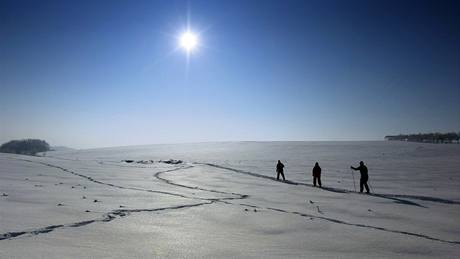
top-left (385, 132), bottom-right (460, 143)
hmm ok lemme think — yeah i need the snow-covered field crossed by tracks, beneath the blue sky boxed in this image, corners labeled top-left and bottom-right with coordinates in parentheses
top-left (0, 142), bottom-right (460, 258)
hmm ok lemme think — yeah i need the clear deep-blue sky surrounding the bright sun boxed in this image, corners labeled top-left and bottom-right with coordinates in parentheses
top-left (0, 0), bottom-right (460, 148)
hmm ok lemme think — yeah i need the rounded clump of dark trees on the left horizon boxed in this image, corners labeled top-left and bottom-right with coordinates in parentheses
top-left (0, 139), bottom-right (50, 155)
